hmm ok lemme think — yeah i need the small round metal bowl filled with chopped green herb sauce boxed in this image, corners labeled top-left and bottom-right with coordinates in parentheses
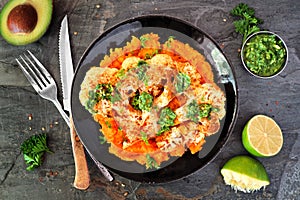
top-left (241, 31), bottom-right (288, 78)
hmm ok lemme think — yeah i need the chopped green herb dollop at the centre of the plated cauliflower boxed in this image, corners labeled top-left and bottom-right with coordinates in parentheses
top-left (130, 91), bottom-right (153, 112)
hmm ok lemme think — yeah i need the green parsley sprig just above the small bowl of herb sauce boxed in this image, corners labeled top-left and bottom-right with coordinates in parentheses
top-left (230, 3), bottom-right (263, 42)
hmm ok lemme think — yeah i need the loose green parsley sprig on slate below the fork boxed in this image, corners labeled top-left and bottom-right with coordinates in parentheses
top-left (21, 133), bottom-right (52, 171)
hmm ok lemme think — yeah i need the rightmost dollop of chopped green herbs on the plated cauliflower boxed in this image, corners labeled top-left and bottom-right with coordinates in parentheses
top-left (186, 100), bottom-right (212, 123)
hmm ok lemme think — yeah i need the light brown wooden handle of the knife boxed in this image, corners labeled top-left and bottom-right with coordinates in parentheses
top-left (70, 116), bottom-right (90, 190)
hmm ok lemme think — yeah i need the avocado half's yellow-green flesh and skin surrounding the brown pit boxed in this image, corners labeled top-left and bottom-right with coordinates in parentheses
top-left (0, 0), bottom-right (53, 46)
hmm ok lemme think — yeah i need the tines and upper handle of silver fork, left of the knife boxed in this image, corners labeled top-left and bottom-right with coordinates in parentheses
top-left (16, 50), bottom-right (70, 127)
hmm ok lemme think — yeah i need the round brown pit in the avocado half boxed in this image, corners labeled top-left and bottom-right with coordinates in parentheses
top-left (7, 4), bottom-right (38, 34)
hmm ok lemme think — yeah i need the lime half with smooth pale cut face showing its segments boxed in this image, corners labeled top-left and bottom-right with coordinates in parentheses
top-left (242, 115), bottom-right (283, 157)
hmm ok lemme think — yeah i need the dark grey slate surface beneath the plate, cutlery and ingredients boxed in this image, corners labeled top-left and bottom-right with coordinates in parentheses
top-left (0, 0), bottom-right (300, 200)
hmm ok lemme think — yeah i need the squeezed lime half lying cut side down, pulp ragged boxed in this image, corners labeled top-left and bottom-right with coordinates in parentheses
top-left (221, 155), bottom-right (270, 193)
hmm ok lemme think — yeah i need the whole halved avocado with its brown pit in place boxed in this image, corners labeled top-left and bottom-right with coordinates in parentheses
top-left (0, 0), bottom-right (53, 45)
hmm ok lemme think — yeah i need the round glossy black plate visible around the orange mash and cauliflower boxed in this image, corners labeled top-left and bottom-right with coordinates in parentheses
top-left (71, 15), bottom-right (237, 183)
